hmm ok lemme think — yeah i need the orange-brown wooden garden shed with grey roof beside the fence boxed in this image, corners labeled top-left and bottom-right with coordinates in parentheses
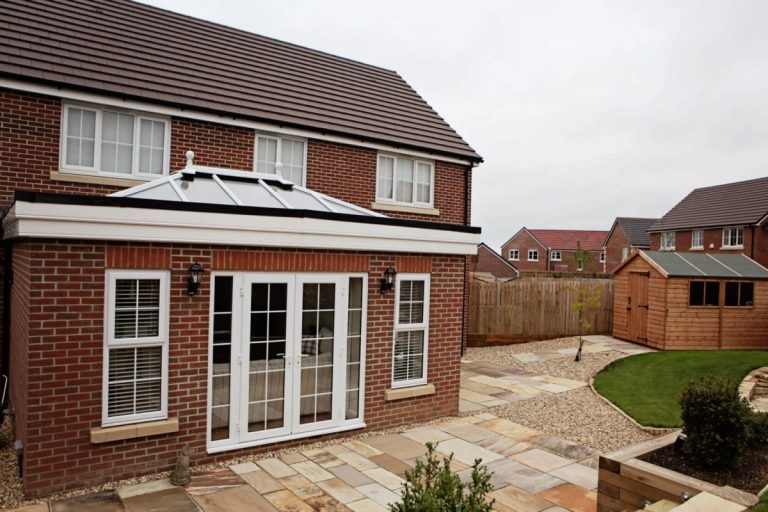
top-left (613, 251), bottom-right (768, 350)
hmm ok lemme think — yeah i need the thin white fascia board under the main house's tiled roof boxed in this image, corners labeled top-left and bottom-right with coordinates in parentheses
top-left (0, 78), bottom-right (478, 167)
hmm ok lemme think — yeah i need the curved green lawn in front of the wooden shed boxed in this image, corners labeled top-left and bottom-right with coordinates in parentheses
top-left (595, 350), bottom-right (768, 427)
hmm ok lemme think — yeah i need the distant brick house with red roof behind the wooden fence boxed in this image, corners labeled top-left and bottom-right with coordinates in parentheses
top-left (501, 227), bottom-right (608, 273)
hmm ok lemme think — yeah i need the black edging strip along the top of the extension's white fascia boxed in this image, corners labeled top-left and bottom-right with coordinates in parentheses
top-left (13, 190), bottom-right (480, 234)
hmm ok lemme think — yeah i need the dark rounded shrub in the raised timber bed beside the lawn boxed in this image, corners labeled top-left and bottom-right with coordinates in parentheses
top-left (680, 378), bottom-right (759, 468)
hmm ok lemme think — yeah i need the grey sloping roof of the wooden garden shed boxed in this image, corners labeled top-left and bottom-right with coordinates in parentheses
top-left (639, 251), bottom-right (768, 279)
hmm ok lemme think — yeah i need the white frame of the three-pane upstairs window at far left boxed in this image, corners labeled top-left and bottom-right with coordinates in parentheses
top-left (59, 101), bottom-right (171, 181)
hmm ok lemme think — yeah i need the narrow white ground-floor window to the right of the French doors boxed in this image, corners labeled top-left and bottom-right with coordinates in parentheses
top-left (392, 274), bottom-right (430, 388)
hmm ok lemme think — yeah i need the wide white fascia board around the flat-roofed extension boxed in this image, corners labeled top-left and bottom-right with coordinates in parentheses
top-left (3, 201), bottom-right (480, 255)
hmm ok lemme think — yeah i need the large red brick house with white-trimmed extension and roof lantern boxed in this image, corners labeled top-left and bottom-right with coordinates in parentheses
top-left (0, 1), bottom-right (482, 496)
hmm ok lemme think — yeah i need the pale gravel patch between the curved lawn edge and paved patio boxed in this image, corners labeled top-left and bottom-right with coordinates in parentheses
top-left (489, 387), bottom-right (654, 453)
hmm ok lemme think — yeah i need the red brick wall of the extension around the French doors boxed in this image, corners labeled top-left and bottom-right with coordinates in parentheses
top-left (12, 241), bottom-right (465, 495)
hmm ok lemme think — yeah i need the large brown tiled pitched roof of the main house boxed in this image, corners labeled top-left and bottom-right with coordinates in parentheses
top-left (0, 0), bottom-right (482, 161)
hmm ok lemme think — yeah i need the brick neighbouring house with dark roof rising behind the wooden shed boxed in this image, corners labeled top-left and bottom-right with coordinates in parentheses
top-left (649, 178), bottom-right (768, 266)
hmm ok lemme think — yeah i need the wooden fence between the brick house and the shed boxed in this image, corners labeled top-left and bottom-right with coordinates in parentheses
top-left (469, 278), bottom-right (613, 346)
